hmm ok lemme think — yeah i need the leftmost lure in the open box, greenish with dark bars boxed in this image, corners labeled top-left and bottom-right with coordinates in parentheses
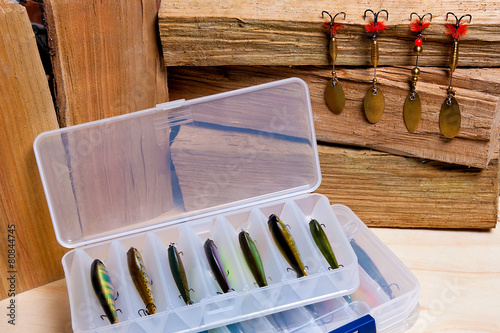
top-left (90, 259), bottom-right (118, 324)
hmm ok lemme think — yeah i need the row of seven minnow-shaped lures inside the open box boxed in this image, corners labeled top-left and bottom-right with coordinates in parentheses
top-left (90, 214), bottom-right (339, 324)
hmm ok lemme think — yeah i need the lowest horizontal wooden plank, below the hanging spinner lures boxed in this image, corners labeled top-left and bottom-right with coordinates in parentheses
top-left (317, 145), bottom-right (499, 229)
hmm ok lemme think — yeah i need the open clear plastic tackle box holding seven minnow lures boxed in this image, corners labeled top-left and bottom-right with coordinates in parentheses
top-left (34, 78), bottom-right (360, 332)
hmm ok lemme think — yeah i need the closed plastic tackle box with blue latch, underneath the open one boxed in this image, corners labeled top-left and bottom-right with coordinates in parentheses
top-left (202, 205), bottom-right (420, 333)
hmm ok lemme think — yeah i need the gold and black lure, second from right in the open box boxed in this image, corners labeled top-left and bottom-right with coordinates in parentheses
top-left (267, 214), bottom-right (307, 277)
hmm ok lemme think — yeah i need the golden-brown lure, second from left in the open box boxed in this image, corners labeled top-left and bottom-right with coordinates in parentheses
top-left (127, 247), bottom-right (156, 315)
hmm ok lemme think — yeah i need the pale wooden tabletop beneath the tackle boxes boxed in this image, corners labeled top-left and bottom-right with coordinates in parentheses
top-left (0, 224), bottom-right (500, 333)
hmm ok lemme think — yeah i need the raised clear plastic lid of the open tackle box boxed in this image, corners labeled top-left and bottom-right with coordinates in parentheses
top-left (34, 78), bottom-right (321, 247)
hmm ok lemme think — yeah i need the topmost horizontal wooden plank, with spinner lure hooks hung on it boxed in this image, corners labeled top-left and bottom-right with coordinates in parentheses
top-left (159, 0), bottom-right (500, 67)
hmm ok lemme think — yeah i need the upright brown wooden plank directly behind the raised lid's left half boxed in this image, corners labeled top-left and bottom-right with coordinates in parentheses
top-left (44, 0), bottom-right (168, 126)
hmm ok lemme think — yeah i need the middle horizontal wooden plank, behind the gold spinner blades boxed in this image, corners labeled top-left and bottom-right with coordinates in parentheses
top-left (170, 66), bottom-right (500, 168)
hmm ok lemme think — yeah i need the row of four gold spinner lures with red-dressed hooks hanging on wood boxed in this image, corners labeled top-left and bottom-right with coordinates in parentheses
top-left (322, 9), bottom-right (472, 139)
